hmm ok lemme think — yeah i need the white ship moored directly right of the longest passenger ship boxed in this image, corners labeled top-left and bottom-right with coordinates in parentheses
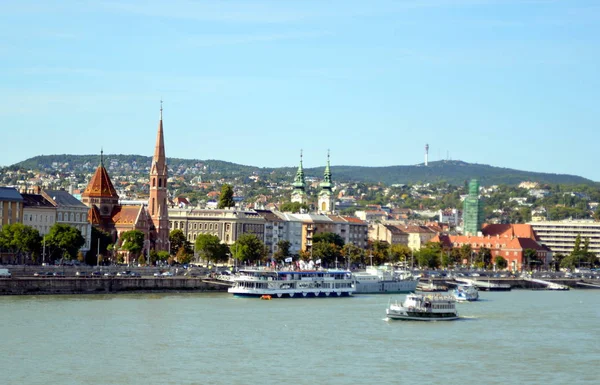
top-left (353, 266), bottom-right (419, 294)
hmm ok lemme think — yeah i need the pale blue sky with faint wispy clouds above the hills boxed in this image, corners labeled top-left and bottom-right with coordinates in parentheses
top-left (0, 0), bottom-right (600, 181)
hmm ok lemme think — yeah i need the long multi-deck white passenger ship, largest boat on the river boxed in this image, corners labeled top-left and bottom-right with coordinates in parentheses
top-left (227, 269), bottom-right (356, 298)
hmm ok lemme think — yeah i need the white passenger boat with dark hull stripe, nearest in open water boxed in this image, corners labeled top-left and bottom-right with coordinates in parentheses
top-left (386, 294), bottom-right (458, 321)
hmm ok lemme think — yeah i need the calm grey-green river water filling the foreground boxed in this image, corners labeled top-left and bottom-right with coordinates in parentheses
top-left (0, 290), bottom-right (600, 385)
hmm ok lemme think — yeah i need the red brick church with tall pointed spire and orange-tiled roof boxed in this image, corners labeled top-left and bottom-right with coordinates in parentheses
top-left (81, 105), bottom-right (169, 255)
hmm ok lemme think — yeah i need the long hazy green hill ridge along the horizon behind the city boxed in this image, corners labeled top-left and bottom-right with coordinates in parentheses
top-left (9, 154), bottom-right (594, 185)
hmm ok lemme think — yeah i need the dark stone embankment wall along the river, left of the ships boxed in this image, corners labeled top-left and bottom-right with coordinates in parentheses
top-left (0, 277), bottom-right (227, 295)
